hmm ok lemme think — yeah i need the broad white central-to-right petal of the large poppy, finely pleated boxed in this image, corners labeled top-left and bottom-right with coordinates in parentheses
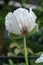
top-left (13, 8), bottom-right (36, 32)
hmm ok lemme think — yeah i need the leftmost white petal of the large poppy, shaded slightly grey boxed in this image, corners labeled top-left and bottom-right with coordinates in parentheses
top-left (5, 13), bottom-right (21, 34)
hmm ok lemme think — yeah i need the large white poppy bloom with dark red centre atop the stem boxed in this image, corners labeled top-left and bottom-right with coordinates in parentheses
top-left (5, 8), bottom-right (37, 34)
